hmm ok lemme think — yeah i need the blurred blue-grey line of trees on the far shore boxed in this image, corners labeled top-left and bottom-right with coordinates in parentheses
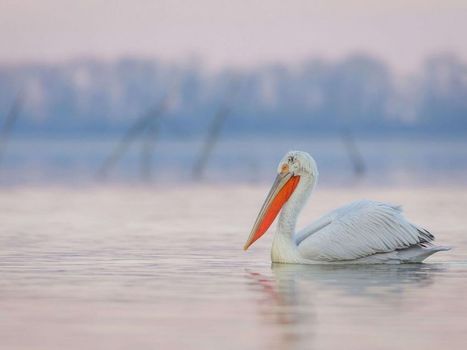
top-left (0, 55), bottom-right (467, 137)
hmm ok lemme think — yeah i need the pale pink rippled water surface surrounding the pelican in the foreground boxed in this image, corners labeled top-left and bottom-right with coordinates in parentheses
top-left (0, 185), bottom-right (467, 350)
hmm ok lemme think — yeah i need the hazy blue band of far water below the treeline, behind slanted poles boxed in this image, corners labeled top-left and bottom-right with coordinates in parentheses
top-left (0, 135), bottom-right (467, 187)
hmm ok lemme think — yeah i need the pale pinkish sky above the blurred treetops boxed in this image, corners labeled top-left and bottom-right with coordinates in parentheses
top-left (0, 0), bottom-right (467, 71)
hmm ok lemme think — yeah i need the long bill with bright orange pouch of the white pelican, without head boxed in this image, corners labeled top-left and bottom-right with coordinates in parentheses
top-left (243, 171), bottom-right (300, 250)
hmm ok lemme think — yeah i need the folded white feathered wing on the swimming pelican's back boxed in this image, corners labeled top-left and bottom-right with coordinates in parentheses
top-left (295, 200), bottom-right (434, 261)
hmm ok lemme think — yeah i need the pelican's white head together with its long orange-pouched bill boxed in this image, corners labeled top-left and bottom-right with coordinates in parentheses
top-left (243, 151), bottom-right (318, 250)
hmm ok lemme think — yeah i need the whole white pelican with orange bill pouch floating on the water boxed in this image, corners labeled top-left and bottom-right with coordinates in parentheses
top-left (244, 151), bottom-right (450, 264)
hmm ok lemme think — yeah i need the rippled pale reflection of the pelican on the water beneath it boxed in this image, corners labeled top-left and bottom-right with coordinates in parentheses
top-left (246, 263), bottom-right (444, 349)
